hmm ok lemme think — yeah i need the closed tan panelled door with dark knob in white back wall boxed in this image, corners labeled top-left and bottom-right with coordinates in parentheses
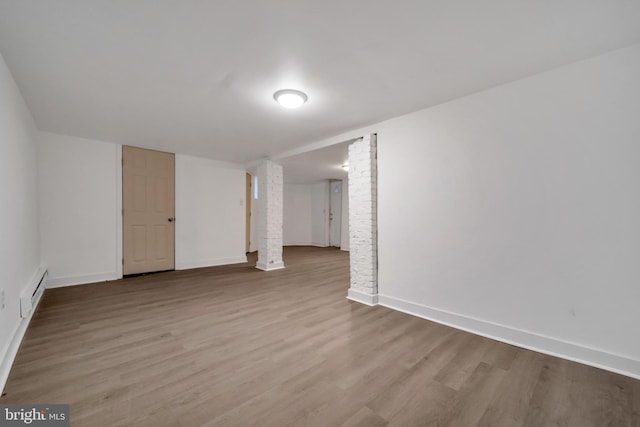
top-left (122, 146), bottom-right (175, 275)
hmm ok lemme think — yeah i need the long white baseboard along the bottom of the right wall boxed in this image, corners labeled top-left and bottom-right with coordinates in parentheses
top-left (376, 289), bottom-right (640, 379)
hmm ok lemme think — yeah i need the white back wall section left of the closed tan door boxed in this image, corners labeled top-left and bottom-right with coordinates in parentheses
top-left (39, 132), bottom-right (122, 286)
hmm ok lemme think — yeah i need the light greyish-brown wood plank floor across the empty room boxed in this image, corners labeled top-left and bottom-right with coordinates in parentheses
top-left (0, 248), bottom-right (640, 427)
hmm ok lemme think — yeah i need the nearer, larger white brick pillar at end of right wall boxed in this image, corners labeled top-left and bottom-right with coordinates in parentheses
top-left (347, 134), bottom-right (378, 305)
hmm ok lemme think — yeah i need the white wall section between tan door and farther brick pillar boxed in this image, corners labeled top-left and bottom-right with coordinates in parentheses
top-left (176, 155), bottom-right (247, 270)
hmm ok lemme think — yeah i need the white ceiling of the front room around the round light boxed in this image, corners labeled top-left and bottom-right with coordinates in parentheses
top-left (0, 0), bottom-right (640, 163)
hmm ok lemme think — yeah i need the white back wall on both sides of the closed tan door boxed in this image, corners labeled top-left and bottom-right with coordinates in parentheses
top-left (39, 132), bottom-right (246, 286)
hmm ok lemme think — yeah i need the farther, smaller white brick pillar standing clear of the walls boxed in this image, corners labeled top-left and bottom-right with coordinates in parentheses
top-left (256, 160), bottom-right (284, 271)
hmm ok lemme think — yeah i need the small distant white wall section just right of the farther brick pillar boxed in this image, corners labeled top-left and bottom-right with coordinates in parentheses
top-left (283, 184), bottom-right (312, 246)
